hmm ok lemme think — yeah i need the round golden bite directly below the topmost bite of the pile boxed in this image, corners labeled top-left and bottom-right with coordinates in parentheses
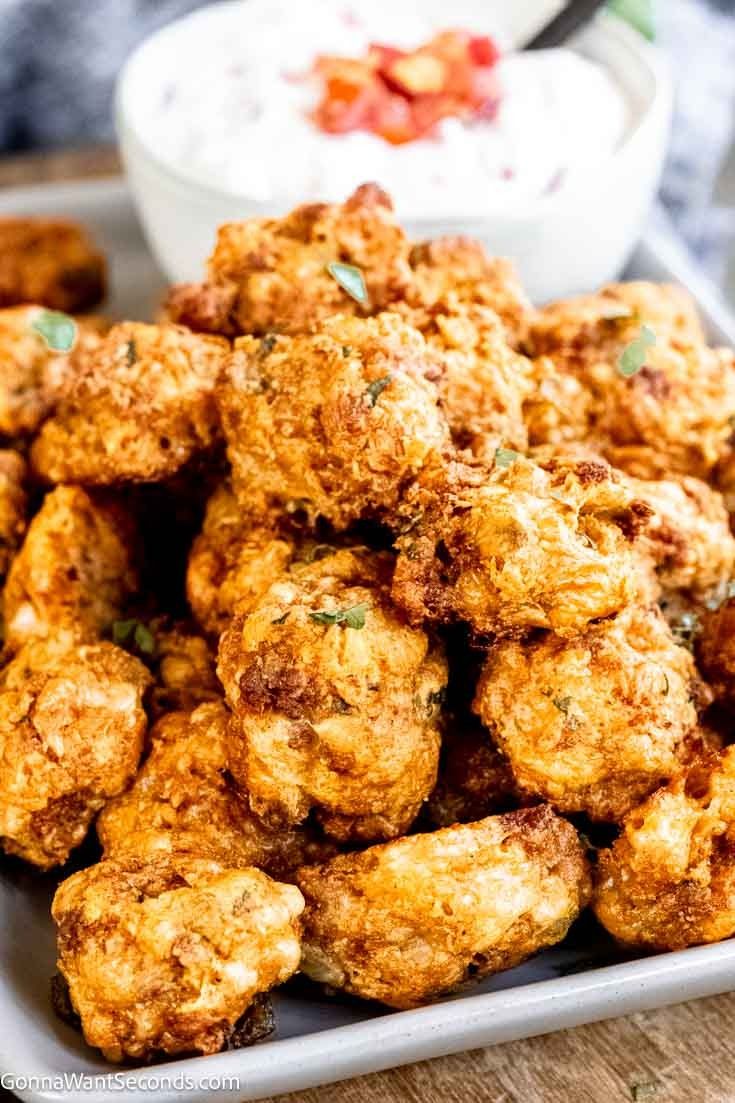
top-left (219, 314), bottom-right (449, 528)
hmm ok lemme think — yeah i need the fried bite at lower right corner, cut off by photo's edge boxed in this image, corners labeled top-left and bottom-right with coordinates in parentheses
top-left (593, 747), bottom-right (735, 950)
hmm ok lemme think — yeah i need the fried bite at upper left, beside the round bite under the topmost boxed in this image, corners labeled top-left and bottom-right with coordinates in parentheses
top-left (31, 322), bottom-right (228, 485)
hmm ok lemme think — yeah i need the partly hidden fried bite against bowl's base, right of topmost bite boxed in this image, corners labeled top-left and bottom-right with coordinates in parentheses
top-left (405, 237), bottom-right (533, 347)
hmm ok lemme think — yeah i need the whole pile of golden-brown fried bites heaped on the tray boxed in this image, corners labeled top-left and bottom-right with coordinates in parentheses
top-left (0, 185), bottom-right (735, 1061)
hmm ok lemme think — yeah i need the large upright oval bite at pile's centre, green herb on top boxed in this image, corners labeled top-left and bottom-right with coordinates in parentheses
top-left (217, 550), bottom-right (447, 839)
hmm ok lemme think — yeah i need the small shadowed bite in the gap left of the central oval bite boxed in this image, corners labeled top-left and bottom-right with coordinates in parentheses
top-left (149, 618), bottom-right (222, 717)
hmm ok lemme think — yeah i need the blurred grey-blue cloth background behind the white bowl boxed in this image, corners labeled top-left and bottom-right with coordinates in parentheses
top-left (0, 0), bottom-right (735, 301)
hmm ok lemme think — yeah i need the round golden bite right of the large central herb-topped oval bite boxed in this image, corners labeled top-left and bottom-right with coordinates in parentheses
top-left (473, 606), bottom-right (700, 821)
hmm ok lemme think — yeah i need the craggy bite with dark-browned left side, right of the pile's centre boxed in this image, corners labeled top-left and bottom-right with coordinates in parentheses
top-left (393, 457), bottom-right (649, 635)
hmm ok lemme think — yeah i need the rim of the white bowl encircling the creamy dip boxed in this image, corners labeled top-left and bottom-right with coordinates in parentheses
top-left (114, 0), bottom-right (673, 226)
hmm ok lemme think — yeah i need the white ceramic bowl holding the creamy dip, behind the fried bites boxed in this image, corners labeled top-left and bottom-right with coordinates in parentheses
top-left (116, 0), bottom-right (672, 302)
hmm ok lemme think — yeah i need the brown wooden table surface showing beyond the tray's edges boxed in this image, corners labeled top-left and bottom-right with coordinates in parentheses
top-left (0, 149), bottom-right (735, 1103)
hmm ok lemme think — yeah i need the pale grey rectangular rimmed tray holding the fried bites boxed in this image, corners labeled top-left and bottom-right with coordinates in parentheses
top-left (0, 181), bottom-right (735, 1103)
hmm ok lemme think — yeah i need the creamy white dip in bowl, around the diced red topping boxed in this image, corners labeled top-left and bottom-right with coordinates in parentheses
top-left (127, 0), bottom-right (630, 217)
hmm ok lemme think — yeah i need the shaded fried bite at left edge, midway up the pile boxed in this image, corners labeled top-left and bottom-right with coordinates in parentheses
top-left (2, 486), bottom-right (138, 650)
